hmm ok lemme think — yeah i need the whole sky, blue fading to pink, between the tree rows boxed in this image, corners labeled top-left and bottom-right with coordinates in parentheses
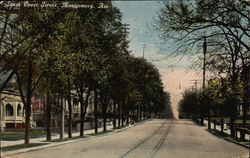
top-left (112, 1), bottom-right (204, 118)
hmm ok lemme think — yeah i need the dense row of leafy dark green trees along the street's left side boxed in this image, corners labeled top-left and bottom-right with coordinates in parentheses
top-left (0, 1), bottom-right (173, 144)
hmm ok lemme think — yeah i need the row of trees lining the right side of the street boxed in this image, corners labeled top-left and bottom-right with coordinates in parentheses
top-left (156, 0), bottom-right (250, 141)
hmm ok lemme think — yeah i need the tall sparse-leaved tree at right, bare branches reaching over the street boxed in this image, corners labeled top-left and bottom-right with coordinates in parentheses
top-left (156, 0), bottom-right (250, 136)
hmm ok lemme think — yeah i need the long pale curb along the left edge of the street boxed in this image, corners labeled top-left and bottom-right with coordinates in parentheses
top-left (0, 119), bottom-right (154, 158)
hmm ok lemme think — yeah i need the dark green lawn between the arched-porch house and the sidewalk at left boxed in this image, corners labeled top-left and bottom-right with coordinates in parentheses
top-left (0, 132), bottom-right (45, 141)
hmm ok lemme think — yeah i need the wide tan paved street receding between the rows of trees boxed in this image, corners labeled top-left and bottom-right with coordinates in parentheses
top-left (6, 120), bottom-right (249, 158)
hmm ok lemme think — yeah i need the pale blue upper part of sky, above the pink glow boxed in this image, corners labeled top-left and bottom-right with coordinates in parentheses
top-left (112, 1), bottom-right (188, 69)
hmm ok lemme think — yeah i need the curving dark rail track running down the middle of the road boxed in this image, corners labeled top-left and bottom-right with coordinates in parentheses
top-left (119, 120), bottom-right (172, 158)
